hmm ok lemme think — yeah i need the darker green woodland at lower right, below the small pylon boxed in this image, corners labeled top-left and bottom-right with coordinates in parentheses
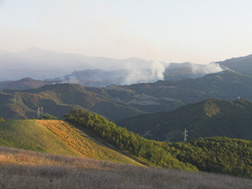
top-left (160, 137), bottom-right (252, 178)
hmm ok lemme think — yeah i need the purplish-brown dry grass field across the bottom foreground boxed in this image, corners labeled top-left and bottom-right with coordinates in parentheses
top-left (0, 147), bottom-right (252, 189)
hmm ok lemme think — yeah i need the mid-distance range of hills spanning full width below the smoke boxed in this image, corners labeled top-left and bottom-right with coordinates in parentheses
top-left (0, 71), bottom-right (252, 120)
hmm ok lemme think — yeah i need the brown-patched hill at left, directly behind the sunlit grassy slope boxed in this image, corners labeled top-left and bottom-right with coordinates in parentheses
top-left (0, 84), bottom-right (144, 119)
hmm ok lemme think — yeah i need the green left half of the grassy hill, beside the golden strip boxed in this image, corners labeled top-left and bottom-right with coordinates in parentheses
top-left (0, 120), bottom-right (78, 155)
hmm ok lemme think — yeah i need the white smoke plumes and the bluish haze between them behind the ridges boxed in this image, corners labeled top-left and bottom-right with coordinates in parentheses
top-left (64, 61), bottom-right (223, 87)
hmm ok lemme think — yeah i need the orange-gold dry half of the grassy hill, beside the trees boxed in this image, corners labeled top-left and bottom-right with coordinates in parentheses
top-left (37, 120), bottom-right (140, 165)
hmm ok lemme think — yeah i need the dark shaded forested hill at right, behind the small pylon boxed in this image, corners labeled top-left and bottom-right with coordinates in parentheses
top-left (116, 99), bottom-right (252, 141)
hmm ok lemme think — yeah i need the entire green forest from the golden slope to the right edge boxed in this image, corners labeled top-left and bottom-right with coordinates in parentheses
top-left (65, 109), bottom-right (252, 177)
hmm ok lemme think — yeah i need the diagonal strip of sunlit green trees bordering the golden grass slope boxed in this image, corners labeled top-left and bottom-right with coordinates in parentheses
top-left (65, 109), bottom-right (197, 171)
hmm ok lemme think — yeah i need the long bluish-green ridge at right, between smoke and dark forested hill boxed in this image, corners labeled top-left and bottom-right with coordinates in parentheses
top-left (105, 71), bottom-right (252, 113)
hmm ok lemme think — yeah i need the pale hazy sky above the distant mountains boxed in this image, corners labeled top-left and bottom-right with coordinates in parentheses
top-left (0, 0), bottom-right (252, 64)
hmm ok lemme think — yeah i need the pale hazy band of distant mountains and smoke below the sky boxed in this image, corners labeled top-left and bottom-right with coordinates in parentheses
top-left (0, 48), bottom-right (223, 87)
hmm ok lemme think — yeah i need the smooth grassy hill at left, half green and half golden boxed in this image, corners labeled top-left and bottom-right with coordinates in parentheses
top-left (0, 120), bottom-right (139, 165)
